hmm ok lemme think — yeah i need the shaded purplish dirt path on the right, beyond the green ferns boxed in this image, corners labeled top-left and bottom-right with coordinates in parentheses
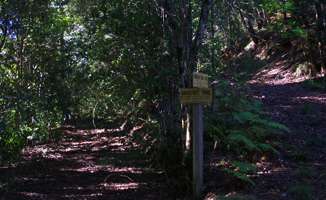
top-left (248, 74), bottom-right (326, 200)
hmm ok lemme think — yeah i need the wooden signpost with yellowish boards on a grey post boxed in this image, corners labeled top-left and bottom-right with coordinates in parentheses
top-left (180, 72), bottom-right (213, 198)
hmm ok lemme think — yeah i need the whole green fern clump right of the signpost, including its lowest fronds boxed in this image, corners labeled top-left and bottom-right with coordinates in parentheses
top-left (206, 81), bottom-right (289, 184)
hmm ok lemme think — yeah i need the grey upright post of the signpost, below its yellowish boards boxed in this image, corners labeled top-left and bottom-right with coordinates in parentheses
top-left (192, 104), bottom-right (204, 199)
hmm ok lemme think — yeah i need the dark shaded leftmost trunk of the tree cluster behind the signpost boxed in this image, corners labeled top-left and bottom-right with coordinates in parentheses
top-left (158, 0), bottom-right (185, 161)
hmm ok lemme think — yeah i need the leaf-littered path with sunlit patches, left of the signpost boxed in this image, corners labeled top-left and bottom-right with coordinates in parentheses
top-left (0, 128), bottom-right (167, 200)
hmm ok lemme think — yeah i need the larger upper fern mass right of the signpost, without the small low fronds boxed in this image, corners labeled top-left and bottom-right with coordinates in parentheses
top-left (207, 79), bottom-right (289, 155)
